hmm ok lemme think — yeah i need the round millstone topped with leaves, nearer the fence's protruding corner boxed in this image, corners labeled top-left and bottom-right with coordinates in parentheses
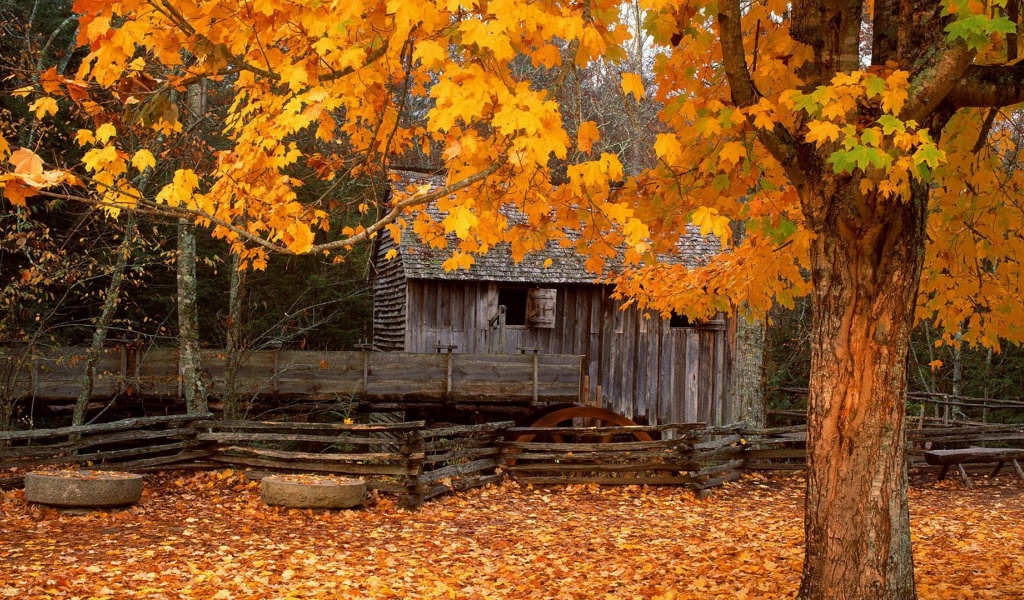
top-left (260, 475), bottom-right (367, 508)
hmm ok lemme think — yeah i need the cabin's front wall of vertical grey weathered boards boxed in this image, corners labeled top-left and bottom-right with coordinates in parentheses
top-left (397, 280), bottom-right (734, 425)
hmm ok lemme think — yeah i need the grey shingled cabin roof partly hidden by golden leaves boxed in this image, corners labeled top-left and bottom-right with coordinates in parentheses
top-left (392, 165), bottom-right (721, 284)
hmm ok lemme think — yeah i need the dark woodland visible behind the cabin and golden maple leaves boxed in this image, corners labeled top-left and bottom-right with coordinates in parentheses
top-left (0, 0), bottom-right (1024, 425)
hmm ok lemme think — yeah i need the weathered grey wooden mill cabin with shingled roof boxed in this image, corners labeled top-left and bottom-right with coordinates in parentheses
top-left (371, 170), bottom-right (739, 425)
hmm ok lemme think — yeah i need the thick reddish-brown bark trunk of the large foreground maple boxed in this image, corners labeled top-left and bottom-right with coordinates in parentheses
top-left (800, 174), bottom-right (928, 600)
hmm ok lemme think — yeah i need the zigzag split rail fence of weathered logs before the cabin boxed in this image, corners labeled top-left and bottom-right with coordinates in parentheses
top-left (0, 416), bottom-right (1024, 507)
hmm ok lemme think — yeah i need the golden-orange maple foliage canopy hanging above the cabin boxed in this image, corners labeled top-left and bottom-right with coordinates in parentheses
top-left (6, 0), bottom-right (1024, 345)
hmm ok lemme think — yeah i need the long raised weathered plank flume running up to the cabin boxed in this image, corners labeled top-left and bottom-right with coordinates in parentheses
top-left (0, 348), bottom-right (582, 404)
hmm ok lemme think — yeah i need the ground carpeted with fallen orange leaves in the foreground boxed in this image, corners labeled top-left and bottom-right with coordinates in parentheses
top-left (0, 471), bottom-right (1024, 599)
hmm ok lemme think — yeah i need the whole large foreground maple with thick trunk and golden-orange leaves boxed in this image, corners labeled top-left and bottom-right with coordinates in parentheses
top-left (6, 0), bottom-right (1024, 599)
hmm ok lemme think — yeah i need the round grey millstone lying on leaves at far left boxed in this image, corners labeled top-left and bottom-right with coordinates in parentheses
top-left (25, 471), bottom-right (142, 508)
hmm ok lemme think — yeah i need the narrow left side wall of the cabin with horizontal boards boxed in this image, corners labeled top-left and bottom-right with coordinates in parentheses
top-left (371, 231), bottom-right (406, 352)
